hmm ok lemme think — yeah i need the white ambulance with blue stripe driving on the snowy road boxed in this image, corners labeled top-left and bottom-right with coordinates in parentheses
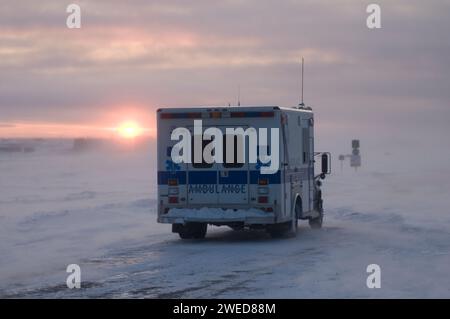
top-left (157, 106), bottom-right (331, 239)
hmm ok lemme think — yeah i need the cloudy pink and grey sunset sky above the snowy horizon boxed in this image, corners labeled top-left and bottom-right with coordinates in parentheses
top-left (0, 0), bottom-right (450, 145)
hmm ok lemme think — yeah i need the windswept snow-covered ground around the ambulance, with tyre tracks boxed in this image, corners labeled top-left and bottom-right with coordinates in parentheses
top-left (0, 142), bottom-right (450, 298)
